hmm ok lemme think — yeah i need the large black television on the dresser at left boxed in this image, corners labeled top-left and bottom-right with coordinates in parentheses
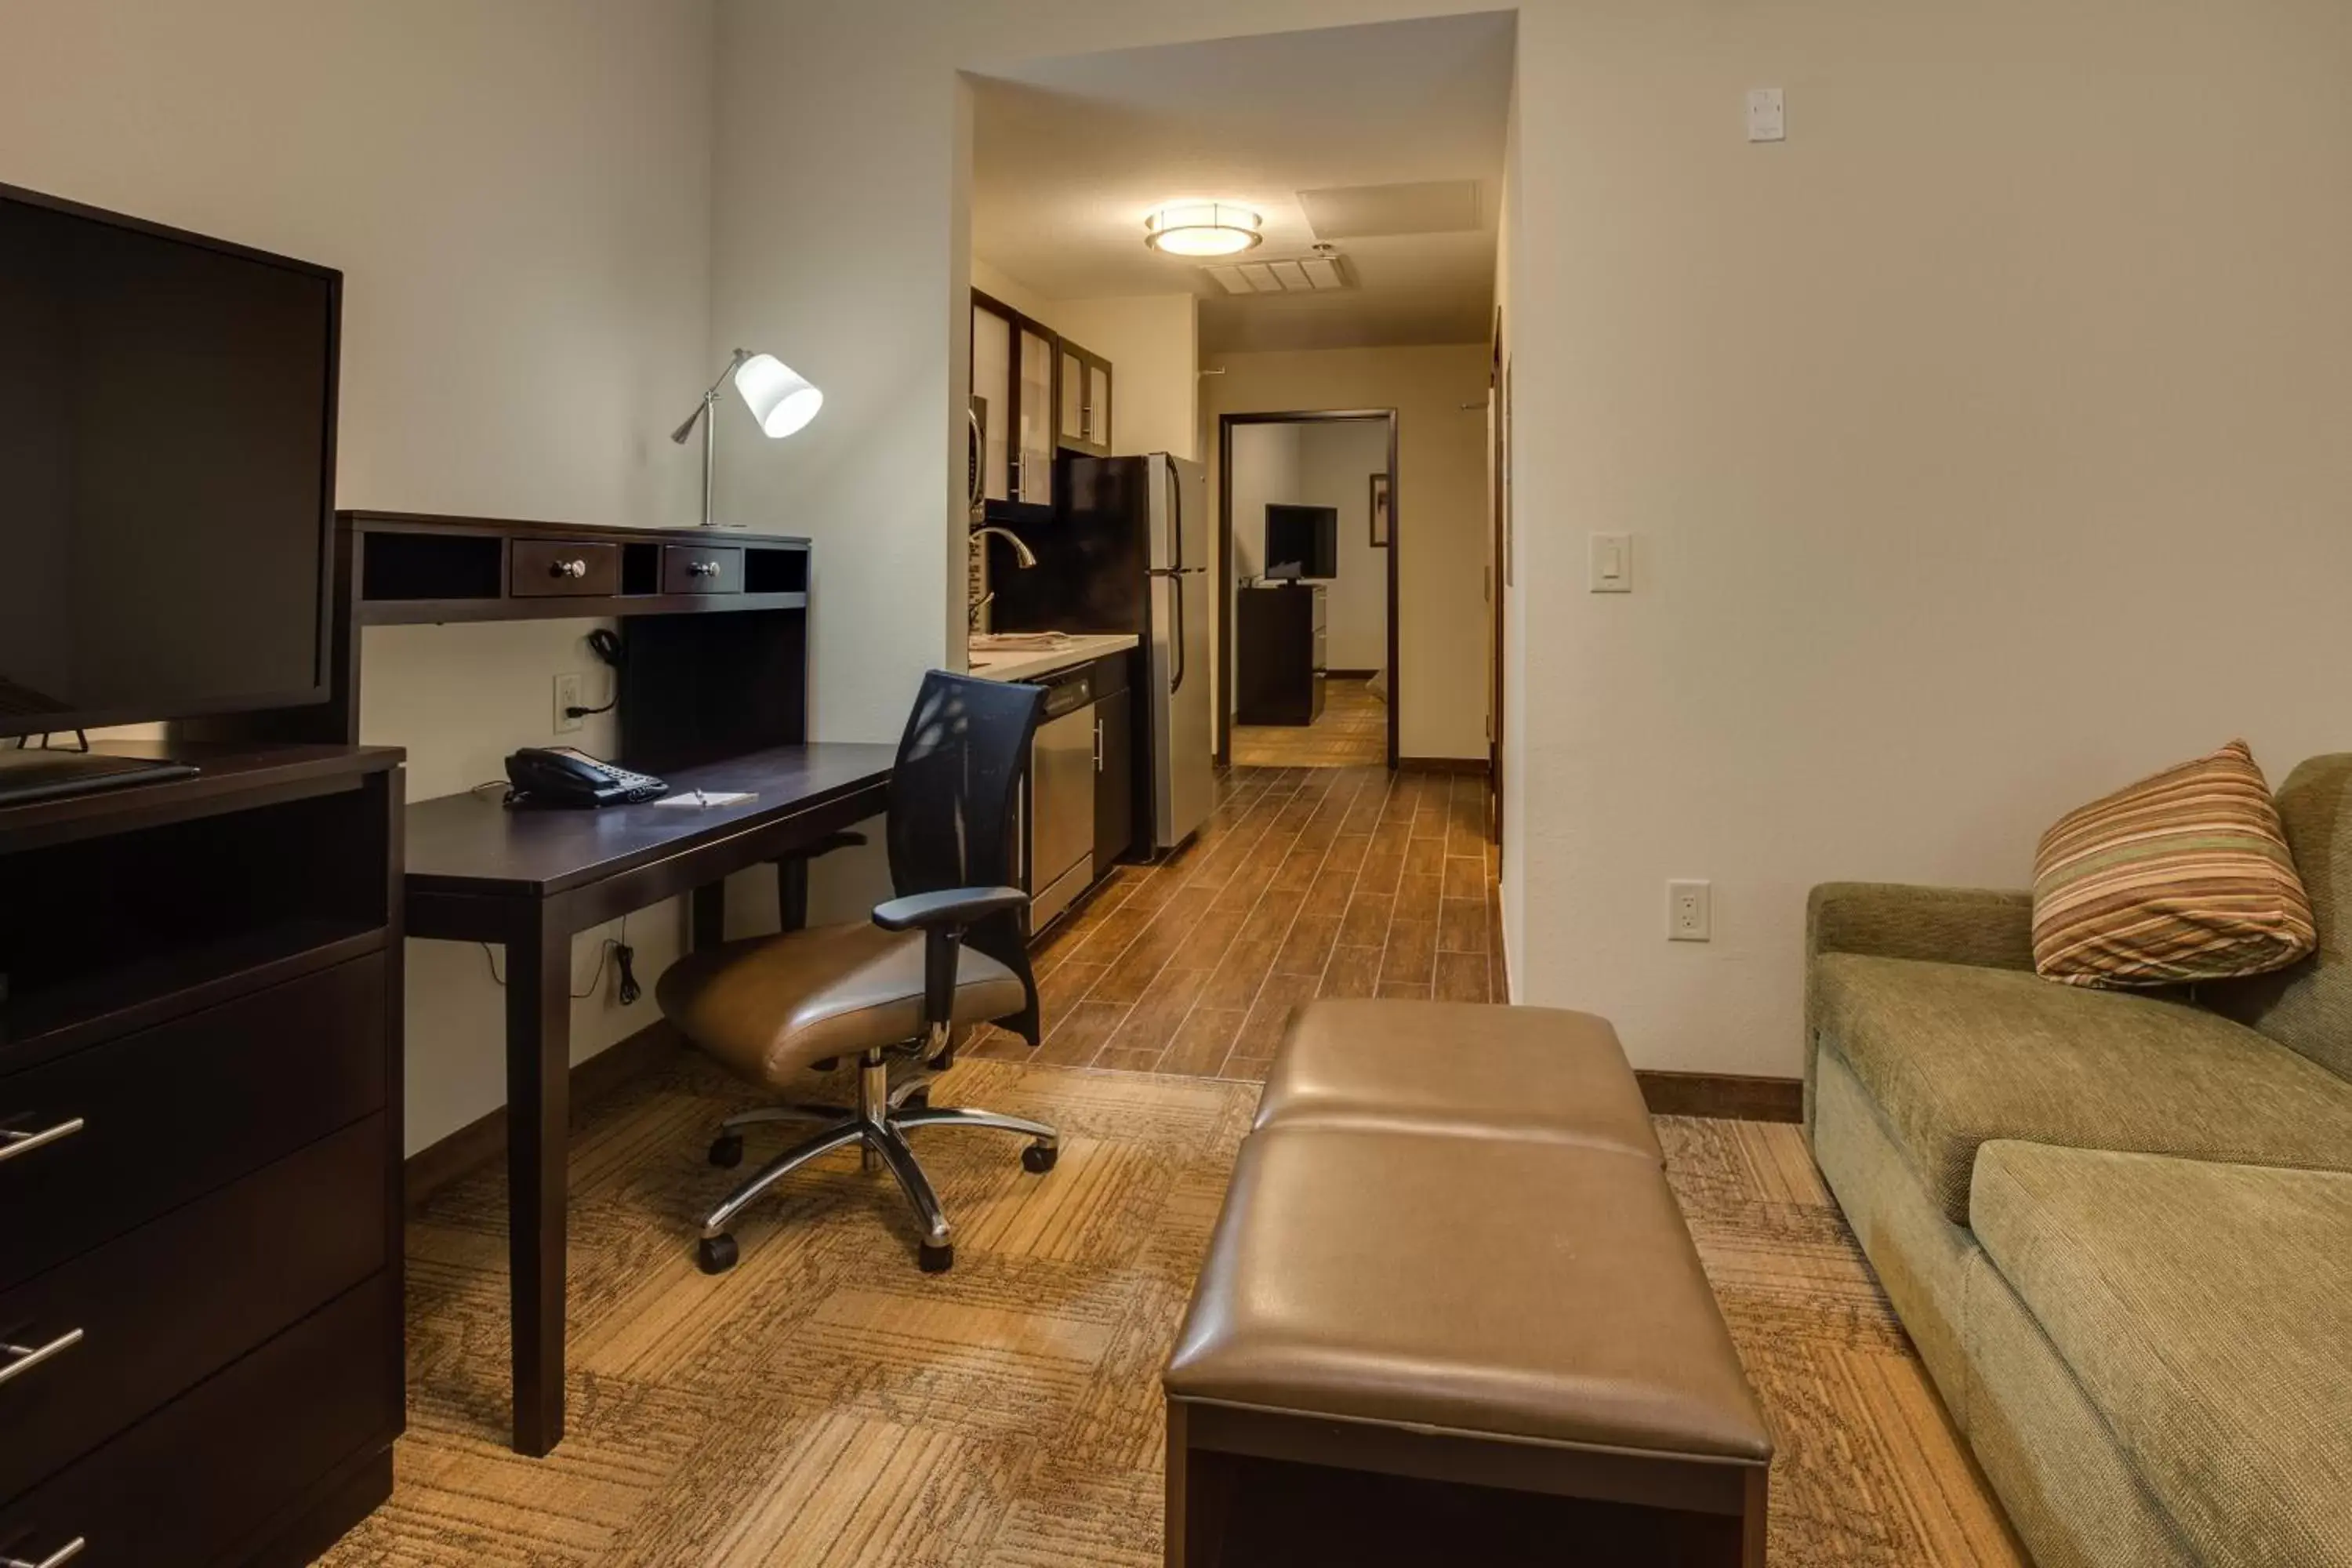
top-left (0, 186), bottom-right (341, 736)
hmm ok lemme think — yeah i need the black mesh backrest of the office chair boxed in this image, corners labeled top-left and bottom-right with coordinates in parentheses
top-left (889, 670), bottom-right (1044, 1046)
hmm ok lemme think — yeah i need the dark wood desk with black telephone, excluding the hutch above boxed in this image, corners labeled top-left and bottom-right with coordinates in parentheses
top-left (405, 743), bottom-right (896, 1457)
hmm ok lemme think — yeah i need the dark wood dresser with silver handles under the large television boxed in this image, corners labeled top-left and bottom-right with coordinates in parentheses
top-left (0, 743), bottom-right (405, 1568)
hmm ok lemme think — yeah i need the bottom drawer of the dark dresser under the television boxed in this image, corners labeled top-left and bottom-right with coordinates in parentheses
top-left (0, 1274), bottom-right (402, 1568)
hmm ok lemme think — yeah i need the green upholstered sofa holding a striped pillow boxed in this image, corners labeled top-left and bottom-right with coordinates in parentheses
top-left (1804, 755), bottom-right (2352, 1568)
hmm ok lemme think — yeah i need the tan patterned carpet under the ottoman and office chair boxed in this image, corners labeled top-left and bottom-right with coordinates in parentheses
top-left (325, 1055), bottom-right (2023, 1568)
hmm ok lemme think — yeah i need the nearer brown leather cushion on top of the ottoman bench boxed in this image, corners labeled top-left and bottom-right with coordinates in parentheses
top-left (1164, 1123), bottom-right (1771, 1467)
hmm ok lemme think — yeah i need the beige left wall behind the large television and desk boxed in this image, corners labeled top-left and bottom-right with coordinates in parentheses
top-left (0, 0), bottom-right (715, 1149)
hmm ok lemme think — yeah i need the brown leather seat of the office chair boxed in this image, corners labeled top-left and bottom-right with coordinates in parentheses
top-left (656, 924), bottom-right (1028, 1083)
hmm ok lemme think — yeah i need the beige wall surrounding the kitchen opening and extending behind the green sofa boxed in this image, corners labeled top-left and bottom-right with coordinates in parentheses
top-left (715, 0), bottom-right (2352, 1072)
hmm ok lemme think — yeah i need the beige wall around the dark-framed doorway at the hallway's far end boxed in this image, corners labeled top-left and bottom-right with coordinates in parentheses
top-left (1202, 343), bottom-right (1486, 757)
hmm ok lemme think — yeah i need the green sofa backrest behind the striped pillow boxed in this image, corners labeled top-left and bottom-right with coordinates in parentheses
top-left (2197, 753), bottom-right (2352, 1079)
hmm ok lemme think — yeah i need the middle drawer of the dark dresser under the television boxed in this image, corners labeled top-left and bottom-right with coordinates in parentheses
top-left (0, 1116), bottom-right (393, 1497)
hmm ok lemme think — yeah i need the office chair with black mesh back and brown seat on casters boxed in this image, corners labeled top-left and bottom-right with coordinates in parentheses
top-left (656, 670), bottom-right (1058, 1274)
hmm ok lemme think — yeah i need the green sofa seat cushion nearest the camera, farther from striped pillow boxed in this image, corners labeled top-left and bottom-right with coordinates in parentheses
top-left (1969, 1142), bottom-right (2352, 1568)
